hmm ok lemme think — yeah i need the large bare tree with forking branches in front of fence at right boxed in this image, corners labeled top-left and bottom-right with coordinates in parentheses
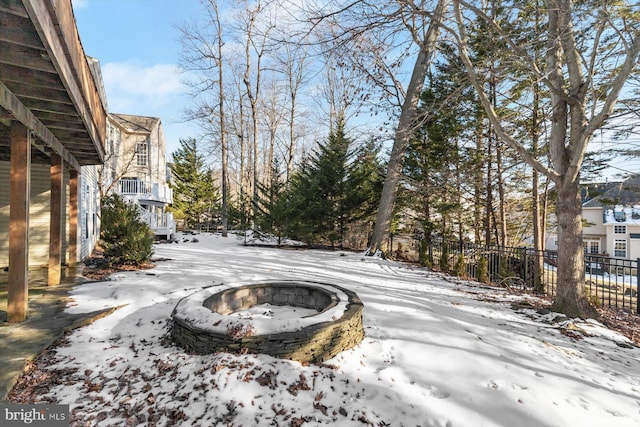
top-left (449, 0), bottom-right (640, 316)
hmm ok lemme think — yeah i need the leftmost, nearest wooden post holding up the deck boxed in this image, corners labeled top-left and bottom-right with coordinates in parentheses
top-left (7, 121), bottom-right (31, 323)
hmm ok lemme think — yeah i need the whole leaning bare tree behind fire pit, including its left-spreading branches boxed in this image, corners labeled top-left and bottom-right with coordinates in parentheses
top-left (300, 0), bottom-right (449, 255)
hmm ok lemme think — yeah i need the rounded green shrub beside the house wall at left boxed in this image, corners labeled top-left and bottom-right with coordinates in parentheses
top-left (100, 194), bottom-right (153, 265)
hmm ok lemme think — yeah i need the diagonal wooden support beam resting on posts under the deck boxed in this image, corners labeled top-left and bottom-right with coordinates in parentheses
top-left (0, 82), bottom-right (80, 170)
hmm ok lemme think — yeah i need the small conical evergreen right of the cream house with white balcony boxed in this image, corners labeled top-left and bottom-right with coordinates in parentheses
top-left (171, 138), bottom-right (219, 228)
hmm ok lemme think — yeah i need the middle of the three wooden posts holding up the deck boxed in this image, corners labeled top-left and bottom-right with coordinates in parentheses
top-left (47, 154), bottom-right (63, 286)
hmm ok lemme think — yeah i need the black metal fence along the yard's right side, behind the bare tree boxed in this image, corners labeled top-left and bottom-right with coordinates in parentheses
top-left (391, 236), bottom-right (640, 314)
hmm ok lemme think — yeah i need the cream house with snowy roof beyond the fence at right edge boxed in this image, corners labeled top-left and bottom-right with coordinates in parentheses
top-left (582, 176), bottom-right (640, 259)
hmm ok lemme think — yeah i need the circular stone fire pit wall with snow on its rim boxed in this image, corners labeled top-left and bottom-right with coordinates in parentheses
top-left (171, 281), bottom-right (364, 363)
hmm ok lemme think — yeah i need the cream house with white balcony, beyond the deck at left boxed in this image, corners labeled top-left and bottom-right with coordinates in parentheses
top-left (103, 113), bottom-right (175, 239)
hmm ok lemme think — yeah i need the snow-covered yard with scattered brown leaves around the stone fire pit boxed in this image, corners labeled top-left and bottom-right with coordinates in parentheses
top-left (32, 235), bottom-right (640, 427)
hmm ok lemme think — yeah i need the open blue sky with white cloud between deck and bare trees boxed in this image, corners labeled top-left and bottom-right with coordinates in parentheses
top-left (73, 0), bottom-right (201, 155)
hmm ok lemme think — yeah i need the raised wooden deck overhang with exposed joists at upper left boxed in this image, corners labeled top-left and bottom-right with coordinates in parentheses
top-left (0, 0), bottom-right (106, 170)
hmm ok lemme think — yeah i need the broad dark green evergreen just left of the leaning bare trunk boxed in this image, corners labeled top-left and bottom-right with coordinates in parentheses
top-left (278, 120), bottom-right (383, 247)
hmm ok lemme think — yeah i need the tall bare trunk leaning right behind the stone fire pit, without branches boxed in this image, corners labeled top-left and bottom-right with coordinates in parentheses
top-left (367, 0), bottom-right (449, 256)
